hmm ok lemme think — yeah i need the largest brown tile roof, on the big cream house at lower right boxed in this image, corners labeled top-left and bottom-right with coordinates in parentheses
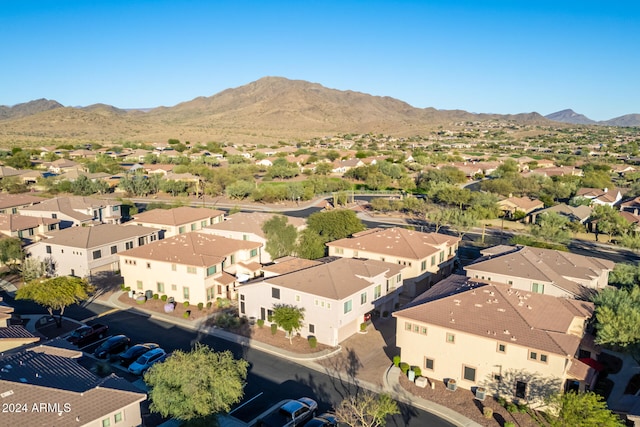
top-left (394, 283), bottom-right (593, 357)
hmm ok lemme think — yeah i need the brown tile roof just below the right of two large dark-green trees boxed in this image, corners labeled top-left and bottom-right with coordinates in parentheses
top-left (327, 227), bottom-right (460, 260)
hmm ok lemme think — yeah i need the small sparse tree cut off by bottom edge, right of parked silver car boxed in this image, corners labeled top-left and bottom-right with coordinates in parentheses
top-left (336, 391), bottom-right (400, 427)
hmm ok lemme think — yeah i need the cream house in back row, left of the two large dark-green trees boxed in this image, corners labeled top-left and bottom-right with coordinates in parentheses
top-left (127, 206), bottom-right (224, 237)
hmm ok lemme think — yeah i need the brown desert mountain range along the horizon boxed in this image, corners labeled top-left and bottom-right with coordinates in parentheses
top-left (0, 77), bottom-right (640, 145)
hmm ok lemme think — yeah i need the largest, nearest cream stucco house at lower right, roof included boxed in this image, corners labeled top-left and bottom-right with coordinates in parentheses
top-left (393, 276), bottom-right (597, 403)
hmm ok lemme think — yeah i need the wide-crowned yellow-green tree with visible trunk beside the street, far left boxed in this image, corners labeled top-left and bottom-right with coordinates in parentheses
top-left (16, 276), bottom-right (93, 328)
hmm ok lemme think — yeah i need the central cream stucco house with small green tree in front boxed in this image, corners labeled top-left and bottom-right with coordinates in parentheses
top-left (238, 257), bottom-right (406, 346)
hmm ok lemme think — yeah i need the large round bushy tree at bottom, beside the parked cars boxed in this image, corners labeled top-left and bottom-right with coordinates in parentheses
top-left (144, 344), bottom-right (249, 421)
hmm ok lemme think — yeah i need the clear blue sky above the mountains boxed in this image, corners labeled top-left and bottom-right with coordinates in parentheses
top-left (0, 0), bottom-right (640, 120)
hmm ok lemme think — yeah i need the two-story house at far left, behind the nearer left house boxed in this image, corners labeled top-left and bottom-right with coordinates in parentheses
top-left (18, 196), bottom-right (122, 228)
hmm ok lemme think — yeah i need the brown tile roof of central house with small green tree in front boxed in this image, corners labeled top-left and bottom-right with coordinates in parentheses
top-left (255, 258), bottom-right (404, 301)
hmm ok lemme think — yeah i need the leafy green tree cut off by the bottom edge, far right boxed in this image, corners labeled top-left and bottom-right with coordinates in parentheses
top-left (549, 391), bottom-right (625, 427)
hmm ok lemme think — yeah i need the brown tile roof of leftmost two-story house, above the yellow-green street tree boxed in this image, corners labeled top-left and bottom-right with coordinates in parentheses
top-left (40, 224), bottom-right (158, 249)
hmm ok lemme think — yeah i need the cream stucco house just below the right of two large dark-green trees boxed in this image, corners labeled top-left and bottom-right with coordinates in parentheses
top-left (327, 227), bottom-right (460, 296)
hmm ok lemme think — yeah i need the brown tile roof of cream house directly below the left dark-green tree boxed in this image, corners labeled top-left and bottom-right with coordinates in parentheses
top-left (119, 232), bottom-right (262, 267)
